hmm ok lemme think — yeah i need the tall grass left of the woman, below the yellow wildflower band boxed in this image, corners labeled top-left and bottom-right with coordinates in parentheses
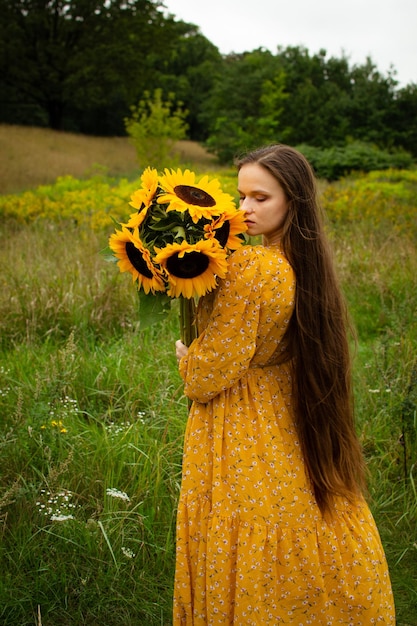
top-left (0, 214), bottom-right (187, 626)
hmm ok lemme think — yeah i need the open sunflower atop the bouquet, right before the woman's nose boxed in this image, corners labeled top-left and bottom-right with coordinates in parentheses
top-left (158, 169), bottom-right (235, 224)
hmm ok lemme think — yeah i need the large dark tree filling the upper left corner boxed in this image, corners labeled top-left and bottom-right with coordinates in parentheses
top-left (0, 0), bottom-right (194, 129)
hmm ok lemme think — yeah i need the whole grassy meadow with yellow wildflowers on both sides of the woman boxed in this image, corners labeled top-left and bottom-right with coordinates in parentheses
top-left (0, 127), bottom-right (417, 626)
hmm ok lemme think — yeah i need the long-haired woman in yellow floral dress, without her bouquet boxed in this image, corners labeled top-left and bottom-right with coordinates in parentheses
top-left (174, 145), bottom-right (395, 626)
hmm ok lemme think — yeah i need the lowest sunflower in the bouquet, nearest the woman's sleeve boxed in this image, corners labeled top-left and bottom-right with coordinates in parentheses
top-left (154, 239), bottom-right (227, 298)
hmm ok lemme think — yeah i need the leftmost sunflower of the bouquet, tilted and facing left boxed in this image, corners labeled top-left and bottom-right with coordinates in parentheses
top-left (109, 227), bottom-right (165, 293)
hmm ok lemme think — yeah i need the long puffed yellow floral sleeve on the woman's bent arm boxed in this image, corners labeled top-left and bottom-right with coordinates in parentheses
top-left (180, 247), bottom-right (262, 402)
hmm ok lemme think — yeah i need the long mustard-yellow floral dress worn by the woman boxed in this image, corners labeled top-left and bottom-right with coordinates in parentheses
top-left (174, 246), bottom-right (395, 626)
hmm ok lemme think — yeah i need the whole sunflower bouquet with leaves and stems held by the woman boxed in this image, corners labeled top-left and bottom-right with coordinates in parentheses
top-left (109, 167), bottom-right (246, 345)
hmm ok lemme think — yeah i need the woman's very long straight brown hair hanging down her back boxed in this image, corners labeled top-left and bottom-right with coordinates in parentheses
top-left (237, 144), bottom-right (365, 513)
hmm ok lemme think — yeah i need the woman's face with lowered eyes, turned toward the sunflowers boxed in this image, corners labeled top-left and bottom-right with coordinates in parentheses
top-left (238, 163), bottom-right (288, 245)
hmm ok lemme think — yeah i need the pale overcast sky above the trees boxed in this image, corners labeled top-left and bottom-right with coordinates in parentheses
top-left (163, 0), bottom-right (417, 86)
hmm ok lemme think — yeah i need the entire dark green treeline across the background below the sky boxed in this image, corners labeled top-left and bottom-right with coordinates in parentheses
top-left (0, 0), bottom-right (417, 163)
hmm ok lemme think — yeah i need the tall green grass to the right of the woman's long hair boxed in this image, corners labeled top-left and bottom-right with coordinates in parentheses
top-left (338, 224), bottom-right (417, 626)
